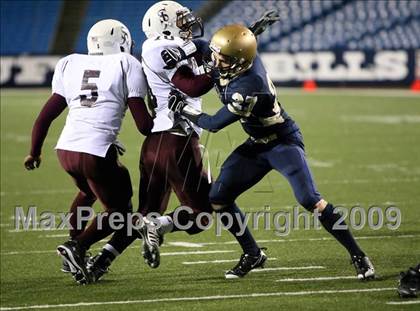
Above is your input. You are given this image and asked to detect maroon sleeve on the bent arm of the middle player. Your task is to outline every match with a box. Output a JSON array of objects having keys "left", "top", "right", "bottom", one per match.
[{"left": 171, "top": 66, "right": 214, "bottom": 97}]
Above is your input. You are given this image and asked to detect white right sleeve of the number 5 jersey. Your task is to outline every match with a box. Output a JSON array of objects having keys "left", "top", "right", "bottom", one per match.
[{"left": 126, "top": 56, "right": 147, "bottom": 98}]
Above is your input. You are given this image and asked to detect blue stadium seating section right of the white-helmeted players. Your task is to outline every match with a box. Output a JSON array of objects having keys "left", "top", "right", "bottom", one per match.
[{"left": 206, "top": 0, "right": 420, "bottom": 52}]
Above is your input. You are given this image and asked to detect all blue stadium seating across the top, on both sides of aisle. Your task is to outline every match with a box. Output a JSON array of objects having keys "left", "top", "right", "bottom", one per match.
[{"left": 1, "top": 0, "right": 420, "bottom": 55}]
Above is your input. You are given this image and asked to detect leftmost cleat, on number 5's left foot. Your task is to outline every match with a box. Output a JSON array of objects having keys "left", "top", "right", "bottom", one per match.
[{"left": 57, "top": 240, "right": 91, "bottom": 284}]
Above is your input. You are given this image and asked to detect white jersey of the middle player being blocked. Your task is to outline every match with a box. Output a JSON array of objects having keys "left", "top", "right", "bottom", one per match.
[{"left": 141, "top": 36, "right": 203, "bottom": 135}]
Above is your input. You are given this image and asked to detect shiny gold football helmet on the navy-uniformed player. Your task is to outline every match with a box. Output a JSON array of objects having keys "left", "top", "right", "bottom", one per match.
[{"left": 210, "top": 24, "right": 257, "bottom": 79}]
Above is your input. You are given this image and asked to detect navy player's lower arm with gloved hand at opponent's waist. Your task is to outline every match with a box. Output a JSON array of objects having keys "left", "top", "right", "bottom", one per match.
[{"left": 168, "top": 90, "right": 240, "bottom": 132}]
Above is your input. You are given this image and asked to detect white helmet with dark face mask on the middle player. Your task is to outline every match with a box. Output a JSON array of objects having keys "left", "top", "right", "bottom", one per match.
[{"left": 142, "top": 1, "right": 203, "bottom": 40}]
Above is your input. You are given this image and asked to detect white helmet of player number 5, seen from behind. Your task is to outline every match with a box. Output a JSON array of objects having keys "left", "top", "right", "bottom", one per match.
[{"left": 87, "top": 19, "right": 133, "bottom": 55}]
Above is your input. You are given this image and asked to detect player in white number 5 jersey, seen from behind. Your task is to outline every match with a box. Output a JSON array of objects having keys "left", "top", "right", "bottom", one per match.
[{"left": 24, "top": 19, "right": 153, "bottom": 283}]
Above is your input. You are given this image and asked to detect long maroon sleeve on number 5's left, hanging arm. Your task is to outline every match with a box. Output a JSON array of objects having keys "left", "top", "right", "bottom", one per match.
[{"left": 30, "top": 93, "right": 67, "bottom": 156}]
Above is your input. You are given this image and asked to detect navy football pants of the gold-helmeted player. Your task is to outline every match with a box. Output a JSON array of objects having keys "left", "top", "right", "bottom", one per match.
[{"left": 210, "top": 131, "right": 321, "bottom": 211}]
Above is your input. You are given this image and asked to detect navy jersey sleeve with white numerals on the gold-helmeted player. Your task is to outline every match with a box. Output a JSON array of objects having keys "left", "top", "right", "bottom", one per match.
[{"left": 226, "top": 79, "right": 261, "bottom": 118}]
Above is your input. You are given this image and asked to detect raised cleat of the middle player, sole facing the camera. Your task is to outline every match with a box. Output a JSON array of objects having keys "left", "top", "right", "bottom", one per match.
[{"left": 138, "top": 218, "right": 162, "bottom": 269}]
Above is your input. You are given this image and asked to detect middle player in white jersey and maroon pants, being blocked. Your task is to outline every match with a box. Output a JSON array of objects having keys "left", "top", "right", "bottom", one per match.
[{"left": 85, "top": 1, "right": 218, "bottom": 277}]
